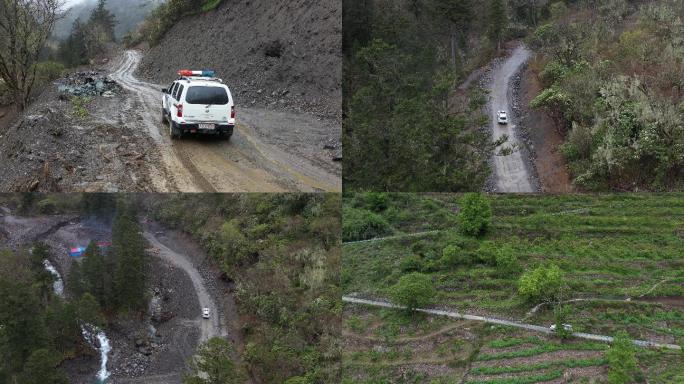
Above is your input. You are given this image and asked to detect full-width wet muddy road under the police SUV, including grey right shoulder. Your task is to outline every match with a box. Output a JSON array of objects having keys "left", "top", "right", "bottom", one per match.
[{"left": 110, "top": 51, "right": 342, "bottom": 192}]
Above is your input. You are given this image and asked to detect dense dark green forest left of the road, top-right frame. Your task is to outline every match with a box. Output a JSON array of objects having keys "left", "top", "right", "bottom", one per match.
[{"left": 343, "top": 0, "right": 542, "bottom": 191}]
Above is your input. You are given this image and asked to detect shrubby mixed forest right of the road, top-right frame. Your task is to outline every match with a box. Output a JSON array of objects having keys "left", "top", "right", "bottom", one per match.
[{"left": 528, "top": 0, "right": 684, "bottom": 190}]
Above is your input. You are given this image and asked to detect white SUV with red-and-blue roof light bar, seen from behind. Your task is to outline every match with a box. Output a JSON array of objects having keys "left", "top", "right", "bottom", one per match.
[{"left": 162, "top": 70, "right": 235, "bottom": 139}]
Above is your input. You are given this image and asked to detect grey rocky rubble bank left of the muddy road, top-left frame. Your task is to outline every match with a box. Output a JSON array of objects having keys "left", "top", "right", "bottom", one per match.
[{"left": 0, "top": 85, "right": 156, "bottom": 192}]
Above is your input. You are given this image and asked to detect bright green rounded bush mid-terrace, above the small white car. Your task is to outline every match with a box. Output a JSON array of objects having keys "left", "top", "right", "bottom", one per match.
[{"left": 518, "top": 265, "right": 564, "bottom": 301}]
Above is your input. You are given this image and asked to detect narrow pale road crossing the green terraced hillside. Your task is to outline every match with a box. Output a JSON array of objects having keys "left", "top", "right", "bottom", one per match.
[{"left": 342, "top": 296, "right": 682, "bottom": 350}]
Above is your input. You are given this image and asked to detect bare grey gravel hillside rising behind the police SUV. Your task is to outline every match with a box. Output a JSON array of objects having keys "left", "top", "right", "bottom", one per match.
[{"left": 139, "top": 0, "right": 342, "bottom": 116}]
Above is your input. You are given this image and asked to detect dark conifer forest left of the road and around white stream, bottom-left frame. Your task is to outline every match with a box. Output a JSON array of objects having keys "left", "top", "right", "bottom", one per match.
[{"left": 0, "top": 194, "right": 147, "bottom": 384}]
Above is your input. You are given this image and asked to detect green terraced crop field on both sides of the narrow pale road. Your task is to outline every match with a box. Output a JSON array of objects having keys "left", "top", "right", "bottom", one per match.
[{"left": 342, "top": 193, "right": 684, "bottom": 384}]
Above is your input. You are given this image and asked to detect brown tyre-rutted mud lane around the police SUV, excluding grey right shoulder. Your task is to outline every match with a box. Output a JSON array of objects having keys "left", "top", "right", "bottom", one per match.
[{"left": 111, "top": 51, "right": 341, "bottom": 192}]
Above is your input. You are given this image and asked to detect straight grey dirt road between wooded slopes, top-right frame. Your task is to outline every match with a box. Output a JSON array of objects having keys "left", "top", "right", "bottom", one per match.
[{"left": 489, "top": 46, "right": 536, "bottom": 193}]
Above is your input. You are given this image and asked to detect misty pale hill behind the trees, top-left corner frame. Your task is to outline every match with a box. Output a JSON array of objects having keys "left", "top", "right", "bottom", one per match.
[{"left": 53, "top": 0, "right": 165, "bottom": 40}]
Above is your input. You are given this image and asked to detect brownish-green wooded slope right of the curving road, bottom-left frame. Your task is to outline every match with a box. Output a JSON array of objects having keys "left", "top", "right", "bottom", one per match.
[{"left": 151, "top": 194, "right": 341, "bottom": 384}]
